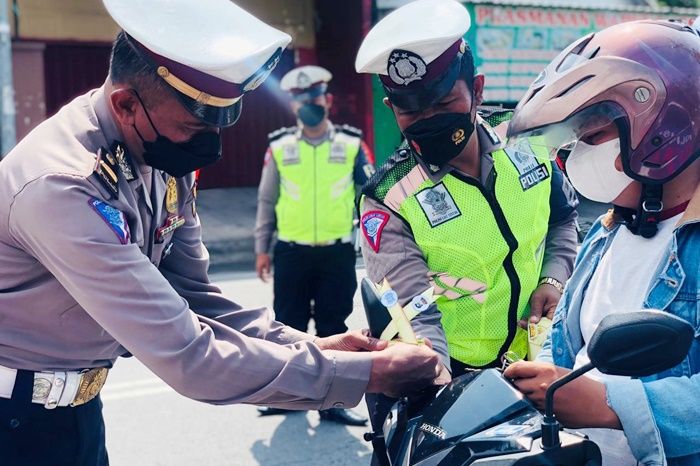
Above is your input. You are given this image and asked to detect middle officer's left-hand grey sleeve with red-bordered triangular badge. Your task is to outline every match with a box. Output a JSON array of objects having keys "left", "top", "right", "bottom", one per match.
[{"left": 360, "top": 197, "right": 450, "bottom": 368}]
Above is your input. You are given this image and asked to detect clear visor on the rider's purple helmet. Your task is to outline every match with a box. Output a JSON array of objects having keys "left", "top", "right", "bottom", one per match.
[{"left": 506, "top": 102, "right": 627, "bottom": 160}]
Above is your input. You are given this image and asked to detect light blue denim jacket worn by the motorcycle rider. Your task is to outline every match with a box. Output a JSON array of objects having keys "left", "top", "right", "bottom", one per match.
[{"left": 538, "top": 189, "right": 700, "bottom": 466}]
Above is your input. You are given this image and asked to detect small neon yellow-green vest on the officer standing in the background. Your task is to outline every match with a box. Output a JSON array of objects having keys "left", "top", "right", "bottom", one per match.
[{"left": 270, "top": 128, "right": 361, "bottom": 244}]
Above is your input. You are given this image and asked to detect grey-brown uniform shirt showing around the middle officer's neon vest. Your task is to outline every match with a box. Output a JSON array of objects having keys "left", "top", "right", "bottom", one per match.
[{"left": 361, "top": 118, "right": 578, "bottom": 367}]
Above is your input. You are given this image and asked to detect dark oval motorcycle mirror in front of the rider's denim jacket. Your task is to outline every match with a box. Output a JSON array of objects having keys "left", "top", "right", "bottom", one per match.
[{"left": 588, "top": 310, "right": 695, "bottom": 377}]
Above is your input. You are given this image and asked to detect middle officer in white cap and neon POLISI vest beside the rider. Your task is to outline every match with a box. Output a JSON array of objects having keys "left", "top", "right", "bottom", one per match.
[{"left": 355, "top": 0, "right": 577, "bottom": 452}]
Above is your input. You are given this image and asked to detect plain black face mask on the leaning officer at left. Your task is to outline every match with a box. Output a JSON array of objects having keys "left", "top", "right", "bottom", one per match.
[{"left": 133, "top": 91, "right": 221, "bottom": 178}]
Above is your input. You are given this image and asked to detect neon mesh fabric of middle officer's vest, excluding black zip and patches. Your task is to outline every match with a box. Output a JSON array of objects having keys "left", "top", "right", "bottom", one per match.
[{"left": 399, "top": 150, "right": 551, "bottom": 367}]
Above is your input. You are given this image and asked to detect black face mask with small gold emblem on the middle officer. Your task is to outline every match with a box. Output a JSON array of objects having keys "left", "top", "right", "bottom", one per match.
[{"left": 403, "top": 113, "right": 474, "bottom": 167}]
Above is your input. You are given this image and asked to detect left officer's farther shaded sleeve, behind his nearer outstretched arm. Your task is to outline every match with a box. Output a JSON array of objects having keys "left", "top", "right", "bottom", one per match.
[{"left": 159, "top": 173, "right": 313, "bottom": 344}]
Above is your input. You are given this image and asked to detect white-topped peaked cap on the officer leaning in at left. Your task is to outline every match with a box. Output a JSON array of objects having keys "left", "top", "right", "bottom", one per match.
[{"left": 103, "top": 0, "right": 291, "bottom": 126}]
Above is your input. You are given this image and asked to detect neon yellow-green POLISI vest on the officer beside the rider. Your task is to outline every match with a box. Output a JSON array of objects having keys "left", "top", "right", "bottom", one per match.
[{"left": 364, "top": 133, "right": 551, "bottom": 367}]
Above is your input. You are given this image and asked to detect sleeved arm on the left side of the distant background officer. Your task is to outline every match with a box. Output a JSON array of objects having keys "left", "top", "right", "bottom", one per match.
[{"left": 255, "top": 147, "right": 280, "bottom": 254}]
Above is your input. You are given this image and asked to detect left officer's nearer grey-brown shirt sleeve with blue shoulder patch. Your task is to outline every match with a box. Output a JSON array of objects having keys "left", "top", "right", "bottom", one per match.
[{"left": 9, "top": 175, "right": 360, "bottom": 409}]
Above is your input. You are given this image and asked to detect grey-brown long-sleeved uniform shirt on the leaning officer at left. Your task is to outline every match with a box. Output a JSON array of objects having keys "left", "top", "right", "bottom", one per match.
[{"left": 0, "top": 89, "right": 371, "bottom": 409}]
